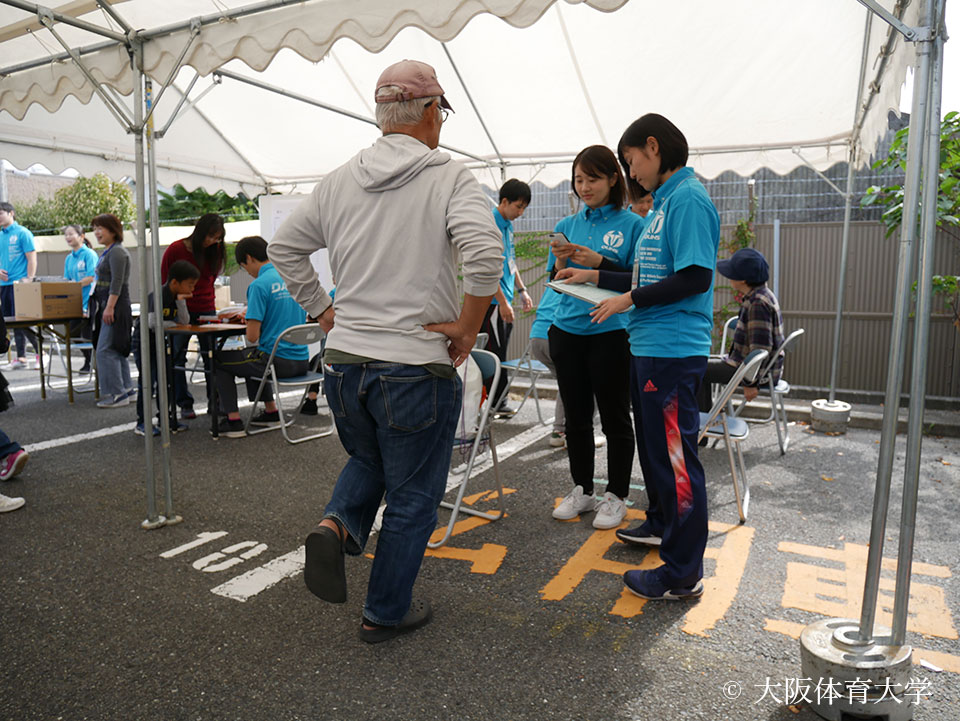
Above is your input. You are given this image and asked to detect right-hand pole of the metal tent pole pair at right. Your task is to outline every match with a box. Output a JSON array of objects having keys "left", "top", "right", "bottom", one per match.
[{"left": 893, "top": 0, "right": 944, "bottom": 646}]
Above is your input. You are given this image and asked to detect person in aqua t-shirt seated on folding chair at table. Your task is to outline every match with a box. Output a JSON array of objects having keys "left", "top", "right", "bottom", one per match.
[{"left": 216, "top": 235, "right": 309, "bottom": 438}]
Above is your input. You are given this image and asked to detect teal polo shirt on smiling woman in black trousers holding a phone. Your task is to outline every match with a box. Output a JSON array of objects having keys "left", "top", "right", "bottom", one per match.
[{"left": 548, "top": 205, "right": 644, "bottom": 335}]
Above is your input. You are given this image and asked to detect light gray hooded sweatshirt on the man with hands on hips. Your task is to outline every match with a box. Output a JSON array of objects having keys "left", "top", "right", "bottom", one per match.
[{"left": 267, "top": 134, "right": 503, "bottom": 365}]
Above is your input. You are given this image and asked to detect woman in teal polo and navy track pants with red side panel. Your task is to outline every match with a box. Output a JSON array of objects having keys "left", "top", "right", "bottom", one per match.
[{"left": 565, "top": 113, "right": 720, "bottom": 600}]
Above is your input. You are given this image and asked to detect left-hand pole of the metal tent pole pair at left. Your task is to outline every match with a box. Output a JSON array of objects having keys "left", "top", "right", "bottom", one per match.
[{"left": 132, "top": 40, "right": 167, "bottom": 529}]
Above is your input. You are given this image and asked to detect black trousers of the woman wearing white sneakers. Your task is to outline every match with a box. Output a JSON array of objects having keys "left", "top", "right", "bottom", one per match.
[{"left": 548, "top": 326, "right": 635, "bottom": 498}]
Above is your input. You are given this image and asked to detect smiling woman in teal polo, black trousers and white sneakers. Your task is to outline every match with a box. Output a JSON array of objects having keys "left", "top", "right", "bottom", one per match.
[{"left": 548, "top": 145, "right": 644, "bottom": 528}]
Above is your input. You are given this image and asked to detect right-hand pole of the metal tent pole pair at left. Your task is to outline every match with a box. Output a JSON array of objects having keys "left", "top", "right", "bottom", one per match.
[{"left": 145, "top": 80, "right": 183, "bottom": 526}]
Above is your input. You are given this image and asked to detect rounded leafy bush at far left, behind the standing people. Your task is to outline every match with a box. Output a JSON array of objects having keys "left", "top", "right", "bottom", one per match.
[{"left": 16, "top": 173, "right": 135, "bottom": 235}]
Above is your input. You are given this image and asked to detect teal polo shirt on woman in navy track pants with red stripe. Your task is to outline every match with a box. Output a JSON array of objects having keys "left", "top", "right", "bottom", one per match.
[{"left": 628, "top": 168, "right": 720, "bottom": 358}]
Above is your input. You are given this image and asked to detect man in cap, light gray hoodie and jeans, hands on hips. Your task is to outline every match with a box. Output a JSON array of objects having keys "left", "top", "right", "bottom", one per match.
[{"left": 267, "top": 60, "right": 503, "bottom": 643}]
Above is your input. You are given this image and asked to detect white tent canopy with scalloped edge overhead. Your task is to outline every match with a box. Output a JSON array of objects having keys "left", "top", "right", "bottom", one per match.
[{"left": 0, "top": 0, "right": 917, "bottom": 193}]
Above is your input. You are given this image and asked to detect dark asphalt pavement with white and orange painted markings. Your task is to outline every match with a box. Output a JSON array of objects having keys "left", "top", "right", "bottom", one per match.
[{"left": 0, "top": 371, "right": 960, "bottom": 721}]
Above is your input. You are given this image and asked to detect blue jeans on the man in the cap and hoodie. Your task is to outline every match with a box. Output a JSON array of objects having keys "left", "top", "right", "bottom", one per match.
[{"left": 323, "top": 362, "right": 462, "bottom": 626}]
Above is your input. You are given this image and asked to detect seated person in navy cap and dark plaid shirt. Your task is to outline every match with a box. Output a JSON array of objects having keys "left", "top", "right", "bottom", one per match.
[{"left": 698, "top": 248, "right": 783, "bottom": 413}]
